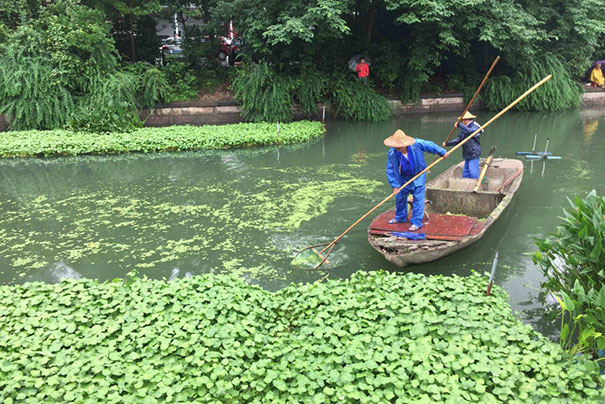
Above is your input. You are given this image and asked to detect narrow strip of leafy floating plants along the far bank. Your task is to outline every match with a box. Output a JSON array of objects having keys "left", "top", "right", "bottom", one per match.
[{"left": 0, "top": 121, "right": 323, "bottom": 157}]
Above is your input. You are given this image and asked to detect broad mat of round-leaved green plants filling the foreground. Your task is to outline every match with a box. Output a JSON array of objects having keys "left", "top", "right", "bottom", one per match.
[{"left": 0, "top": 272, "right": 605, "bottom": 403}]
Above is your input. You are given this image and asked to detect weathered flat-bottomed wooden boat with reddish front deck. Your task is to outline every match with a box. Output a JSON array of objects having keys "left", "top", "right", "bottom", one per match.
[{"left": 368, "top": 159, "right": 523, "bottom": 267}]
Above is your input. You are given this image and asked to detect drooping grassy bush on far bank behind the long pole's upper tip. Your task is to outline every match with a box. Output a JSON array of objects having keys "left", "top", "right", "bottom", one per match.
[{"left": 481, "top": 56, "right": 582, "bottom": 111}]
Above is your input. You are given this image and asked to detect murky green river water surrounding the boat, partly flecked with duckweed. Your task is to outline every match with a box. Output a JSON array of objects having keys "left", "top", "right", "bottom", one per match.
[{"left": 0, "top": 110, "right": 605, "bottom": 333}]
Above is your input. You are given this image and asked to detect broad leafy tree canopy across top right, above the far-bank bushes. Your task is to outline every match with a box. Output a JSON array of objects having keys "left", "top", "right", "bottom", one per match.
[{"left": 211, "top": 0, "right": 605, "bottom": 109}]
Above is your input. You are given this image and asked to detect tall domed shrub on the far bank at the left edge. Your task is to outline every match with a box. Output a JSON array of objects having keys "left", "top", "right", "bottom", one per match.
[{"left": 0, "top": 0, "right": 117, "bottom": 129}]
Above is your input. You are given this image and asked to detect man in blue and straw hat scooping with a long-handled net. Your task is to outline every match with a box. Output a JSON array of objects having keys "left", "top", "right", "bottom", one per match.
[{"left": 384, "top": 129, "right": 448, "bottom": 231}]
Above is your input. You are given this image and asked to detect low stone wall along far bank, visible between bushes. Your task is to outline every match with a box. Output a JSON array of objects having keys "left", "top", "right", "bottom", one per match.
[{"left": 0, "top": 88, "right": 605, "bottom": 131}]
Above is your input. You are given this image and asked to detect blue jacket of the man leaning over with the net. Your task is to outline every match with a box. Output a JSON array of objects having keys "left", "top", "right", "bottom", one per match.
[{"left": 387, "top": 138, "right": 446, "bottom": 188}]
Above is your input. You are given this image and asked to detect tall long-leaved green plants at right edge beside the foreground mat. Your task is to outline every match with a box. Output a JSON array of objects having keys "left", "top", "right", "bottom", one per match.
[{"left": 533, "top": 190, "right": 605, "bottom": 357}]
